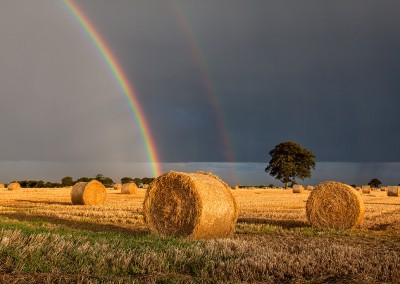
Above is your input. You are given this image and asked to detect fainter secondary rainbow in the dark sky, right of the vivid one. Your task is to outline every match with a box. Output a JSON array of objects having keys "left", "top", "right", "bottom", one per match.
[{"left": 171, "top": 0, "right": 235, "bottom": 162}]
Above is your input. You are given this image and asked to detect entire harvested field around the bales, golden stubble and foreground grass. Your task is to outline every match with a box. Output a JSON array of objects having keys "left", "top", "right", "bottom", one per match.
[{"left": 0, "top": 188, "right": 400, "bottom": 283}]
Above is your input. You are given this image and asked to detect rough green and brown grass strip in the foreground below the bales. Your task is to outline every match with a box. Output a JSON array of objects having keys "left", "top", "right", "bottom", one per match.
[{"left": 0, "top": 218, "right": 400, "bottom": 283}]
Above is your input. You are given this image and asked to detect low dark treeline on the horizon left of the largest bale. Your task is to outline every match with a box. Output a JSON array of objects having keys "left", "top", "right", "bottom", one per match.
[{"left": 9, "top": 174, "right": 154, "bottom": 188}]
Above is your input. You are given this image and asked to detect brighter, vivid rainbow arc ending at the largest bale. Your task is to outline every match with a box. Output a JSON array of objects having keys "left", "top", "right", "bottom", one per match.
[{"left": 63, "top": 0, "right": 162, "bottom": 177}]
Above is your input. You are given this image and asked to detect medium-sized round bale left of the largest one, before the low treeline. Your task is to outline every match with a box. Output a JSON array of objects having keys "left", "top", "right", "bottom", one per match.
[{"left": 71, "top": 180, "right": 106, "bottom": 205}]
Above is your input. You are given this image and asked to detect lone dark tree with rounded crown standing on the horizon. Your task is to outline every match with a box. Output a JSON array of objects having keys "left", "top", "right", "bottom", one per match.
[{"left": 265, "top": 141, "right": 315, "bottom": 188}]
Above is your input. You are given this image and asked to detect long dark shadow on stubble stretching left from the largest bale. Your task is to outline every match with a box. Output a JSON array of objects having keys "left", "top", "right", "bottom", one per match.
[{"left": 0, "top": 212, "right": 149, "bottom": 236}]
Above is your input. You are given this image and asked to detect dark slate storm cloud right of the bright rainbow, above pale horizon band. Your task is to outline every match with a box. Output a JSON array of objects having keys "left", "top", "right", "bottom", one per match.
[{"left": 73, "top": 1, "right": 400, "bottom": 161}]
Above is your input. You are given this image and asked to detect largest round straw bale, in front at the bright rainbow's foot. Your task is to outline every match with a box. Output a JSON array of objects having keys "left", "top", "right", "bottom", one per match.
[{"left": 143, "top": 171, "right": 238, "bottom": 239}]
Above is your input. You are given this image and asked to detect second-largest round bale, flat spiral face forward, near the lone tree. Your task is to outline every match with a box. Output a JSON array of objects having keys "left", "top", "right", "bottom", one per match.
[{"left": 306, "top": 181, "right": 365, "bottom": 229}]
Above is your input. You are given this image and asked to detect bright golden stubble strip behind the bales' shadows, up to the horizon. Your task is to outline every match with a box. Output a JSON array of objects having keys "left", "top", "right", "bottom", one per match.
[{"left": 0, "top": 188, "right": 400, "bottom": 232}]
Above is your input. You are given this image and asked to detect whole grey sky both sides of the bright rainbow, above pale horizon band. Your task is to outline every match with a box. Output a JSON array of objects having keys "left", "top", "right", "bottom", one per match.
[{"left": 0, "top": 0, "right": 400, "bottom": 181}]
